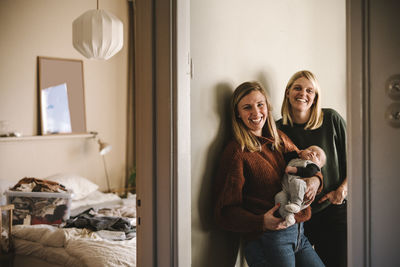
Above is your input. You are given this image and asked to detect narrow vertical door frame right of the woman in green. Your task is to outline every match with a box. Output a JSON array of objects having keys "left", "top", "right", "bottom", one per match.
[{"left": 346, "top": 0, "right": 371, "bottom": 267}]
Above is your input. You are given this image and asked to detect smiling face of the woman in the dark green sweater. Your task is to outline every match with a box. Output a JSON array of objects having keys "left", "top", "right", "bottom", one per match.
[{"left": 286, "top": 77, "right": 316, "bottom": 116}]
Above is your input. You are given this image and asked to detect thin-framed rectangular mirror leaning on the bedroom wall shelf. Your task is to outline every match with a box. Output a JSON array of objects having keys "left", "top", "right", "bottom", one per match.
[{"left": 38, "top": 57, "right": 86, "bottom": 135}]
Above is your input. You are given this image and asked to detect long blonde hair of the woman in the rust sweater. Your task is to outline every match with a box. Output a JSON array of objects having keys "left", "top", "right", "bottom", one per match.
[{"left": 231, "top": 82, "right": 282, "bottom": 152}]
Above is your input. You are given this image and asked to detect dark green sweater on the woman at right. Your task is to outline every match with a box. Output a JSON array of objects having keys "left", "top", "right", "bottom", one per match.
[{"left": 277, "top": 109, "right": 347, "bottom": 216}]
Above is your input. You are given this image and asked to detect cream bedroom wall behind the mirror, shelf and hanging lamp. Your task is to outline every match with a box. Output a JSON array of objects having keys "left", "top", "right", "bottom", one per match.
[{"left": 0, "top": 0, "right": 128, "bottom": 193}]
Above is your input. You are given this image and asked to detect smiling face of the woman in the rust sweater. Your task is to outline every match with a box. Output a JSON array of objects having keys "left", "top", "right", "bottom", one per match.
[{"left": 237, "top": 90, "right": 268, "bottom": 136}]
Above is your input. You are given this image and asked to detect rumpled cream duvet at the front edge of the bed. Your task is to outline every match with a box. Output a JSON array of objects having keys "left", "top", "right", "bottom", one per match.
[{"left": 13, "top": 225, "right": 136, "bottom": 267}]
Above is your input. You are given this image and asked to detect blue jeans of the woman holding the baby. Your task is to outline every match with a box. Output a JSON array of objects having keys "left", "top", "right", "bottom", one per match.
[{"left": 244, "top": 223, "right": 325, "bottom": 267}]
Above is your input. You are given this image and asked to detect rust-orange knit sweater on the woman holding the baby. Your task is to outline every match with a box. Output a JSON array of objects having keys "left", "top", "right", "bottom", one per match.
[{"left": 214, "top": 131, "right": 322, "bottom": 239}]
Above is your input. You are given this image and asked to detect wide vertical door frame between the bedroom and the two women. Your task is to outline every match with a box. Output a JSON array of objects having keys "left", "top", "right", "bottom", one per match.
[{"left": 135, "top": 0, "right": 191, "bottom": 266}]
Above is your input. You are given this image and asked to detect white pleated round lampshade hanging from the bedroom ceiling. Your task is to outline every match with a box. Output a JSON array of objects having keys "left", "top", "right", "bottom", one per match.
[{"left": 72, "top": 9, "right": 124, "bottom": 60}]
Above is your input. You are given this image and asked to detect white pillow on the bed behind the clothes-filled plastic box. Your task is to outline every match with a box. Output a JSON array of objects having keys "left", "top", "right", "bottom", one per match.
[{"left": 44, "top": 173, "right": 99, "bottom": 200}]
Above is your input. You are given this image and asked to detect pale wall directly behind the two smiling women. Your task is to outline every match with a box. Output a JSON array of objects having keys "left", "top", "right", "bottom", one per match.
[{"left": 191, "top": 0, "right": 346, "bottom": 266}]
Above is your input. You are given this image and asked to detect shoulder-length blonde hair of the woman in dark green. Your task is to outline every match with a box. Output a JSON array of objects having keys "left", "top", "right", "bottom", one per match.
[{"left": 281, "top": 70, "right": 324, "bottom": 130}]
